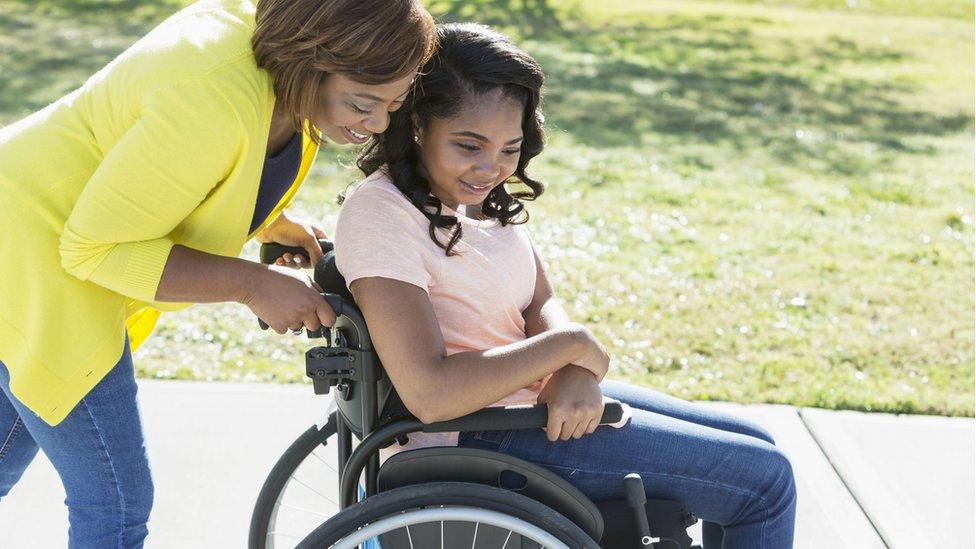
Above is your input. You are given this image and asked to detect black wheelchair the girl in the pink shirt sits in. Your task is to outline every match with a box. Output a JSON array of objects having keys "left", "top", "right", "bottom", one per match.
[{"left": 248, "top": 240, "right": 697, "bottom": 549}]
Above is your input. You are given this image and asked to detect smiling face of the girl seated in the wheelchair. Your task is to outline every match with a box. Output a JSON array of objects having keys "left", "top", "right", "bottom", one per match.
[{"left": 415, "top": 90, "right": 523, "bottom": 210}]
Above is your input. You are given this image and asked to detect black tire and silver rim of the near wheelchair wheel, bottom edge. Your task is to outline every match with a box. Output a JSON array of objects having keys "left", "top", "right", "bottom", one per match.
[{"left": 298, "top": 482, "right": 599, "bottom": 549}]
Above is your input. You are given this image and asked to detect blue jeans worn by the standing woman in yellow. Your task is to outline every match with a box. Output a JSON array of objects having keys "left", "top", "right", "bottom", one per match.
[{"left": 0, "top": 343, "right": 153, "bottom": 549}]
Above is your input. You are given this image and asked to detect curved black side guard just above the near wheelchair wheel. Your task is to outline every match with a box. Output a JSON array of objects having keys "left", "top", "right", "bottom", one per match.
[{"left": 378, "top": 447, "right": 604, "bottom": 540}]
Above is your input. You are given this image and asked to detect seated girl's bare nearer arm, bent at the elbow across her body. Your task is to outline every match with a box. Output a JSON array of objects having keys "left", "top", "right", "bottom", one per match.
[{"left": 350, "top": 277, "right": 605, "bottom": 423}]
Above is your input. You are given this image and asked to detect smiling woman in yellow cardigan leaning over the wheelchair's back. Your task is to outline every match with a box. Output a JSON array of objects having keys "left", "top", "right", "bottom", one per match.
[{"left": 0, "top": 0, "right": 435, "bottom": 548}]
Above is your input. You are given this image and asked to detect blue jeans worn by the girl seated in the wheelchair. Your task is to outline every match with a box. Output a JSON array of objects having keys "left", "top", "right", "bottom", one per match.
[{"left": 458, "top": 381, "right": 796, "bottom": 549}]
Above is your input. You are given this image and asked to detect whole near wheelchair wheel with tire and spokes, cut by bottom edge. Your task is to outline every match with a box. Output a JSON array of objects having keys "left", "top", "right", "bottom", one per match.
[{"left": 298, "top": 482, "right": 599, "bottom": 549}]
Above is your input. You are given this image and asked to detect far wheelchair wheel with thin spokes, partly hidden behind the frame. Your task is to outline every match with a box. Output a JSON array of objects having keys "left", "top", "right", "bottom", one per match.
[{"left": 248, "top": 412, "right": 339, "bottom": 549}]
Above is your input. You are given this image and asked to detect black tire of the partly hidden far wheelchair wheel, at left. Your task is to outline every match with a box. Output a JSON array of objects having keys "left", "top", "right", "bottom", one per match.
[{"left": 247, "top": 412, "right": 336, "bottom": 549}]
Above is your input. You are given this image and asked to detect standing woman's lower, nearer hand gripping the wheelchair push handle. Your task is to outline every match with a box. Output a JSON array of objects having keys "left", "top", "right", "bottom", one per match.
[{"left": 240, "top": 265, "right": 335, "bottom": 334}]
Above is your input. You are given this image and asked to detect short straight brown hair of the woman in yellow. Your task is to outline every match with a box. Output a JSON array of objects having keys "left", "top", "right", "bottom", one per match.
[{"left": 251, "top": 0, "right": 437, "bottom": 146}]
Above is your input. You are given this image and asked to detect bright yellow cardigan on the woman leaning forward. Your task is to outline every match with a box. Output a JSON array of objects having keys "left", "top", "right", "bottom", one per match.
[{"left": 0, "top": 0, "right": 317, "bottom": 425}]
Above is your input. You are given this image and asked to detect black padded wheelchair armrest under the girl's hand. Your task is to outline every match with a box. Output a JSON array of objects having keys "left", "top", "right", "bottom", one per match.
[{"left": 422, "top": 401, "right": 624, "bottom": 433}]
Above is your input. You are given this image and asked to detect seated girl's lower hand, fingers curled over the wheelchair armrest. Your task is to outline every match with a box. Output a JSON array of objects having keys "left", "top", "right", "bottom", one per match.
[{"left": 538, "top": 364, "right": 603, "bottom": 442}]
